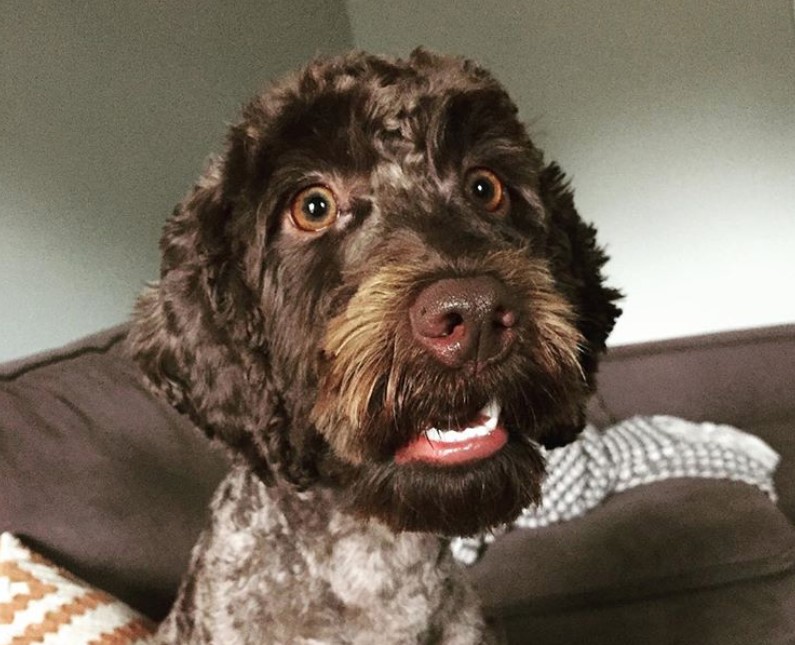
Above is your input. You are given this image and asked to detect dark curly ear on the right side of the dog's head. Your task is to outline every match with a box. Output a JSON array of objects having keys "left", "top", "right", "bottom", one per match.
[{"left": 539, "top": 163, "right": 621, "bottom": 446}]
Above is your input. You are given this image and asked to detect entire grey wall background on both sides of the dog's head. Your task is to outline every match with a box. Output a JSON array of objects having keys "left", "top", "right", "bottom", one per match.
[{"left": 0, "top": 0, "right": 795, "bottom": 360}]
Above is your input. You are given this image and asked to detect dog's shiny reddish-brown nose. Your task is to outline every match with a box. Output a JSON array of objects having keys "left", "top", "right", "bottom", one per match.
[{"left": 409, "top": 276, "right": 517, "bottom": 368}]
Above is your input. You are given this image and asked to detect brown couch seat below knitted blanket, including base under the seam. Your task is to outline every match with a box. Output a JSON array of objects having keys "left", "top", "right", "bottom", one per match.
[{"left": 470, "top": 479, "right": 795, "bottom": 645}]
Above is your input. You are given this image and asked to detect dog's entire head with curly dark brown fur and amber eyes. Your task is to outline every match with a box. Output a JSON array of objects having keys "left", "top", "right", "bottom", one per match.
[{"left": 130, "top": 51, "right": 618, "bottom": 535}]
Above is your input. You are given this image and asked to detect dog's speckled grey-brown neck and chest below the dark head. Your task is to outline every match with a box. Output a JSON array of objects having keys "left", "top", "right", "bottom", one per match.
[{"left": 158, "top": 465, "right": 498, "bottom": 644}]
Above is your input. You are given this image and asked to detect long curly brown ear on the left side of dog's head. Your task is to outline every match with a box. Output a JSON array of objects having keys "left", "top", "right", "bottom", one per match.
[{"left": 128, "top": 128, "right": 302, "bottom": 482}]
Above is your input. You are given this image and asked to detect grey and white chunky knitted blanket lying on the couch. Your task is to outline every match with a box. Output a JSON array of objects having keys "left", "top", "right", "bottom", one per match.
[{"left": 450, "top": 416, "right": 779, "bottom": 564}]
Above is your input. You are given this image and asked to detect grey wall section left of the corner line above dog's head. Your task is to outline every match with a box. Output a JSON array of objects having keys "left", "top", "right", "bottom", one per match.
[{"left": 0, "top": 0, "right": 352, "bottom": 360}]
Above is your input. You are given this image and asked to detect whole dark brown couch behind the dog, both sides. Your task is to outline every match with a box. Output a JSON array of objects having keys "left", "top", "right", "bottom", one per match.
[{"left": 0, "top": 325, "right": 795, "bottom": 645}]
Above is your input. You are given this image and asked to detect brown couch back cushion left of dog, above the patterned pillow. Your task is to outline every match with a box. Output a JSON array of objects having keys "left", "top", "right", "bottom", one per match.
[{"left": 0, "top": 327, "right": 226, "bottom": 617}]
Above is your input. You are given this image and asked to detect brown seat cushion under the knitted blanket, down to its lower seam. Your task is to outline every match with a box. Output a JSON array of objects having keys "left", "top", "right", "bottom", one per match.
[{"left": 470, "top": 479, "right": 795, "bottom": 615}]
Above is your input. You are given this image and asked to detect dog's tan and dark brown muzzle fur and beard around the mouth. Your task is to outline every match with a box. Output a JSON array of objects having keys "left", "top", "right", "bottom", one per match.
[{"left": 311, "top": 252, "right": 586, "bottom": 536}]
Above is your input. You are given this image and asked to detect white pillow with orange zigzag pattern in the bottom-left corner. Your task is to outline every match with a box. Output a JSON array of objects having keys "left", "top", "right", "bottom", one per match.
[{"left": 0, "top": 533, "right": 154, "bottom": 645}]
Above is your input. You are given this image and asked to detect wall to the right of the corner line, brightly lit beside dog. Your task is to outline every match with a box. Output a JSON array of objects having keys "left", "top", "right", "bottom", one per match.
[{"left": 348, "top": 0, "right": 795, "bottom": 343}]
